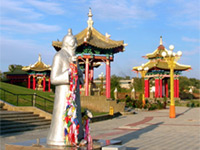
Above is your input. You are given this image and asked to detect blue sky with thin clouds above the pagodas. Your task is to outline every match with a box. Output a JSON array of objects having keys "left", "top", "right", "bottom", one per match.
[{"left": 0, "top": 0, "right": 200, "bottom": 79}]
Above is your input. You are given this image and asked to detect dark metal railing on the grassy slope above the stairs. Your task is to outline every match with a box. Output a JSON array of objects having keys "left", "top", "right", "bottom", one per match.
[{"left": 0, "top": 88, "right": 54, "bottom": 113}]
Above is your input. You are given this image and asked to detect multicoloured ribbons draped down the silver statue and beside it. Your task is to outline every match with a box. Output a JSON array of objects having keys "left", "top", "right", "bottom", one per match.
[{"left": 64, "top": 63, "right": 92, "bottom": 146}]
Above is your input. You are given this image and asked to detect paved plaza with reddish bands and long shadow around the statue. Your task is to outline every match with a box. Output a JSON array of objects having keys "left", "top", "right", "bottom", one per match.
[{"left": 0, "top": 107, "right": 200, "bottom": 150}]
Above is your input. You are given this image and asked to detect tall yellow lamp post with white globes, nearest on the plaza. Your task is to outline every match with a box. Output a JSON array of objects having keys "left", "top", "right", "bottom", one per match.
[{"left": 162, "top": 45, "right": 182, "bottom": 118}]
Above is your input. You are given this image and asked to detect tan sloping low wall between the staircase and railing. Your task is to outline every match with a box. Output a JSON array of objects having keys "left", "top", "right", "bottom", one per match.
[{"left": 0, "top": 100, "right": 52, "bottom": 119}]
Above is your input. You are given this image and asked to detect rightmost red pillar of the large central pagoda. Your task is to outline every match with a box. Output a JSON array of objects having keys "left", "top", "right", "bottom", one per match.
[{"left": 106, "top": 59, "right": 110, "bottom": 98}]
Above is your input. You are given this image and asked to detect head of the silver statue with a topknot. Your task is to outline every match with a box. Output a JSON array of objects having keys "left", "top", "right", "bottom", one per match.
[{"left": 62, "top": 29, "right": 77, "bottom": 51}]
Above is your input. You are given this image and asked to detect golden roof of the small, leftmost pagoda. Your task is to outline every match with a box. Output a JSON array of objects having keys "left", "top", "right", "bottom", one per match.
[{"left": 22, "top": 54, "right": 51, "bottom": 71}]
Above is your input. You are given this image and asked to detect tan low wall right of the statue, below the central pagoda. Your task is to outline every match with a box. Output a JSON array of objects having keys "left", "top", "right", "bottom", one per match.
[{"left": 81, "top": 96, "right": 125, "bottom": 112}]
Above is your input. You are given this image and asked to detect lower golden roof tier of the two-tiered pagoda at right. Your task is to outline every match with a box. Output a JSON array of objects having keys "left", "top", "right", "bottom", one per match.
[{"left": 133, "top": 59, "right": 191, "bottom": 71}]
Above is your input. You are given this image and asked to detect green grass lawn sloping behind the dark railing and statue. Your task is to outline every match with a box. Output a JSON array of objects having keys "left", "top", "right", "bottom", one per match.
[{"left": 0, "top": 82, "right": 108, "bottom": 116}]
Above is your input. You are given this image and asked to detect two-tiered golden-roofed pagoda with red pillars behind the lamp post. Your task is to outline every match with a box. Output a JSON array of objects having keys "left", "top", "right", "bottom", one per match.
[{"left": 133, "top": 36, "right": 191, "bottom": 98}]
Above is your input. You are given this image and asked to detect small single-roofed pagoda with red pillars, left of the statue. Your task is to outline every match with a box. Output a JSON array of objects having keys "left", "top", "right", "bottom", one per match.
[{"left": 22, "top": 54, "right": 51, "bottom": 92}]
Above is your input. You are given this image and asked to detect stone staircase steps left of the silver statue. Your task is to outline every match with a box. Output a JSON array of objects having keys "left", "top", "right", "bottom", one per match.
[{"left": 0, "top": 109, "right": 51, "bottom": 135}]
